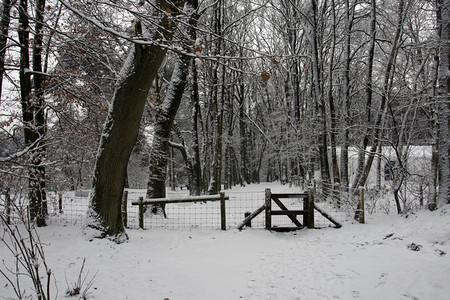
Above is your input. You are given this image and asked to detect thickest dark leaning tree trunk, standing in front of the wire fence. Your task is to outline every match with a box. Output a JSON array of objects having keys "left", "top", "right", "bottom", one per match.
[{"left": 85, "top": 0, "right": 184, "bottom": 242}]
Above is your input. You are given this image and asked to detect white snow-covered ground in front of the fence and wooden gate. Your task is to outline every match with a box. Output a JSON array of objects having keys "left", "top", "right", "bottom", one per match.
[{"left": 0, "top": 185, "right": 450, "bottom": 300}]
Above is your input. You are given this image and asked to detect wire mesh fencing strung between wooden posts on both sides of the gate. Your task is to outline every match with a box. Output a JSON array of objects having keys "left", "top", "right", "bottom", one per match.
[{"left": 0, "top": 189, "right": 348, "bottom": 229}]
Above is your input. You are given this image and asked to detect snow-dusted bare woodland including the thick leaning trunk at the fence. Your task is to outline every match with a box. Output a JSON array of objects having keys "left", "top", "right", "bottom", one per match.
[{"left": 0, "top": 0, "right": 450, "bottom": 237}]
